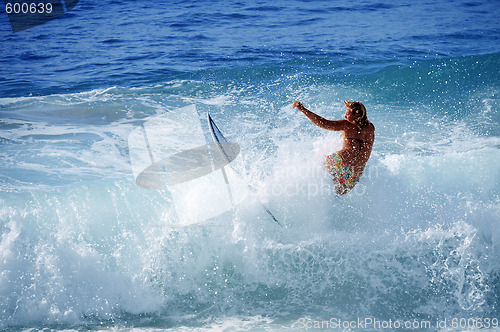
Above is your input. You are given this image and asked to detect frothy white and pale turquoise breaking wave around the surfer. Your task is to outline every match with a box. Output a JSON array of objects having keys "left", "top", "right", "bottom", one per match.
[{"left": 0, "top": 54, "right": 500, "bottom": 331}]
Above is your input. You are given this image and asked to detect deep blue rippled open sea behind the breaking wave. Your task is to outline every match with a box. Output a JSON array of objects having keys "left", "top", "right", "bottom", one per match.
[{"left": 0, "top": 1, "right": 499, "bottom": 97}]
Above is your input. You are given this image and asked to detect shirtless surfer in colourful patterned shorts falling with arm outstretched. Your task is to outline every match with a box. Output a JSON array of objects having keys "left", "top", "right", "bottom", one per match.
[{"left": 292, "top": 100, "right": 375, "bottom": 195}]
